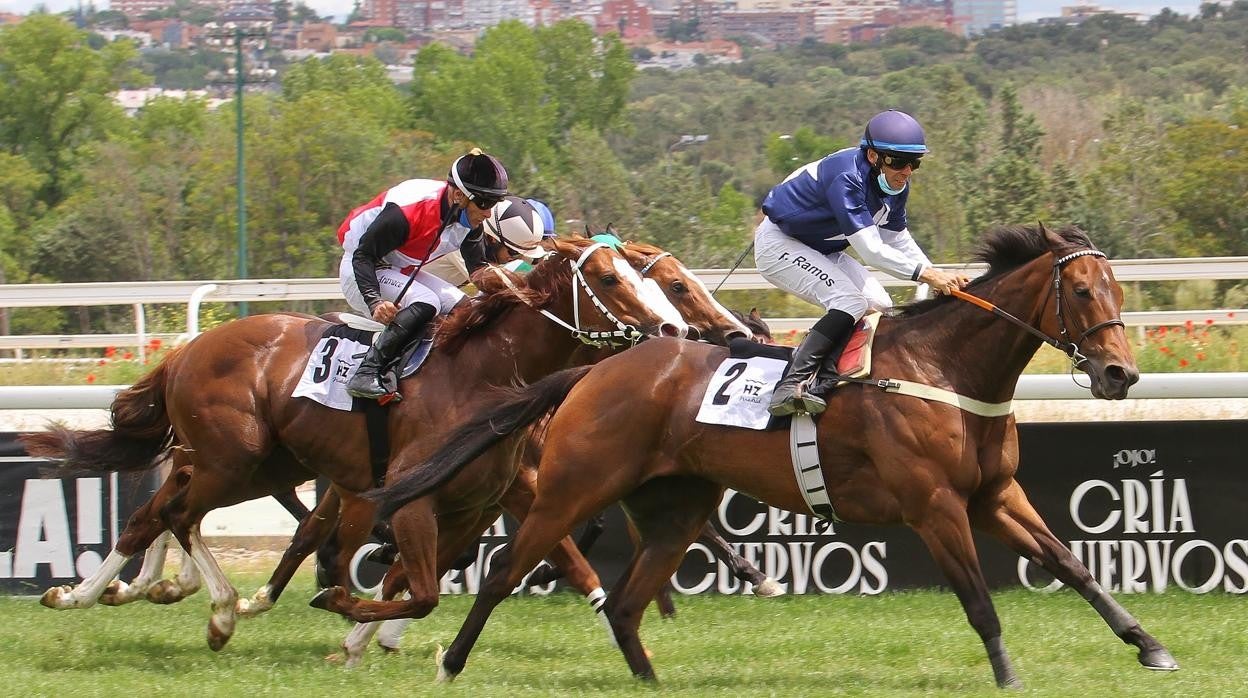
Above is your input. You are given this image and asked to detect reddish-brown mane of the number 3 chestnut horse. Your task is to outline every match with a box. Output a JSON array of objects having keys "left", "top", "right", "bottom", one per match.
[{"left": 433, "top": 237, "right": 594, "bottom": 351}]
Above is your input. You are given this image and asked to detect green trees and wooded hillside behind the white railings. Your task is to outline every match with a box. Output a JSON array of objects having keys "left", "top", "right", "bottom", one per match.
[{"left": 0, "top": 0, "right": 1248, "bottom": 332}]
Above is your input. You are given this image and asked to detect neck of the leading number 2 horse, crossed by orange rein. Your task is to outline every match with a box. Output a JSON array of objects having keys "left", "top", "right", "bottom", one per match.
[{"left": 895, "top": 255, "right": 1053, "bottom": 402}]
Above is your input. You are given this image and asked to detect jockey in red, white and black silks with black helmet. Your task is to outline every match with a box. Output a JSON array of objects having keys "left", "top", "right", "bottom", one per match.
[{"left": 338, "top": 149, "right": 507, "bottom": 398}]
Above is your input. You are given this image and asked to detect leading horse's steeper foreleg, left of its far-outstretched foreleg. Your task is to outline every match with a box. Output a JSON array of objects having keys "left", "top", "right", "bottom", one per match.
[{"left": 907, "top": 491, "right": 1022, "bottom": 688}]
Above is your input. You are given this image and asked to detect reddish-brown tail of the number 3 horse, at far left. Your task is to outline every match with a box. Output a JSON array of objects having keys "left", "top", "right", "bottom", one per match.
[{"left": 19, "top": 348, "right": 181, "bottom": 472}]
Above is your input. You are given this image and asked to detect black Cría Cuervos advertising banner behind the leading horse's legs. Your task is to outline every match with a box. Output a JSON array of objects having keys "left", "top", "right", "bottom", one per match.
[{"left": 344, "top": 421, "right": 1248, "bottom": 594}]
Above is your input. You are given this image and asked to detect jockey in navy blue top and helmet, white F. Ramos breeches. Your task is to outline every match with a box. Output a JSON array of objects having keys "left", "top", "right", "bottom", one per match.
[{"left": 754, "top": 110, "right": 967, "bottom": 416}]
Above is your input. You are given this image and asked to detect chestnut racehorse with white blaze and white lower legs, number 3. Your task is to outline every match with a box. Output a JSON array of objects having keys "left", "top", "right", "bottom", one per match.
[{"left": 22, "top": 240, "right": 685, "bottom": 649}]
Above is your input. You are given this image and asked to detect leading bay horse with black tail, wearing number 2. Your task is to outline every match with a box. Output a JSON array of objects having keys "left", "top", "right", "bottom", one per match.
[{"left": 372, "top": 226, "right": 1177, "bottom": 687}]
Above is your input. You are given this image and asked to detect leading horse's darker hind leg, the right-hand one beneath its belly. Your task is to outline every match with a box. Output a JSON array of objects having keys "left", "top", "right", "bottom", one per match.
[{"left": 607, "top": 477, "right": 724, "bottom": 681}]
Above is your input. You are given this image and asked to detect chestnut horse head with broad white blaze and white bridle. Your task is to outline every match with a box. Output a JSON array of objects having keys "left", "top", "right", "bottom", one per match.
[{"left": 541, "top": 238, "right": 689, "bottom": 341}]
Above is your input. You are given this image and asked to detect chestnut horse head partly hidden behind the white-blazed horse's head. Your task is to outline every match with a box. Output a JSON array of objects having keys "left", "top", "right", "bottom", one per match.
[{"left": 620, "top": 242, "right": 750, "bottom": 346}]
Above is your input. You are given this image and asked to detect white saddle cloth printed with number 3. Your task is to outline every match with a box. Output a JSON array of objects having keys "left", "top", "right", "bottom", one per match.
[{"left": 291, "top": 325, "right": 433, "bottom": 412}]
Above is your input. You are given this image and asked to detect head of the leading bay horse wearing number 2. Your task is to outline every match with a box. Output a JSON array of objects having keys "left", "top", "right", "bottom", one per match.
[{"left": 1040, "top": 225, "right": 1139, "bottom": 400}]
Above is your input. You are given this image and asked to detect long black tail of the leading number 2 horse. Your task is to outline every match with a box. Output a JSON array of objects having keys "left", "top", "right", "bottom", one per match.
[{"left": 362, "top": 366, "right": 592, "bottom": 519}]
